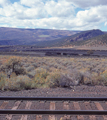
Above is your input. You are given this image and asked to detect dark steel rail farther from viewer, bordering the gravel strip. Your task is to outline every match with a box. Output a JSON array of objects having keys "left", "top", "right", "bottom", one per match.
[{"left": 0, "top": 96, "right": 107, "bottom": 101}]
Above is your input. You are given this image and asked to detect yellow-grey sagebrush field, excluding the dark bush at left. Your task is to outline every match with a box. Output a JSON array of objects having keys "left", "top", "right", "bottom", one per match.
[{"left": 0, "top": 56, "right": 107, "bottom": 90}]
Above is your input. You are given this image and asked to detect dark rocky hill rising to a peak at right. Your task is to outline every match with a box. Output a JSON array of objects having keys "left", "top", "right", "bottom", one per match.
[{"left": 37, "top": 29, "right": 105, "bottom": 46}]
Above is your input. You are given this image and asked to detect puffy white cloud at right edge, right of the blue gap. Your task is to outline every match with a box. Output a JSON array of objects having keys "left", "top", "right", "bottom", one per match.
[{"left": 77, "top": 5, "right": 107, "bottom": 24}]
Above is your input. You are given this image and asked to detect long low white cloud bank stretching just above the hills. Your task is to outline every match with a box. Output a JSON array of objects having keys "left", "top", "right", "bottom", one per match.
[{"left": 0, "top": 13, "right": 104, "bottom": 30}]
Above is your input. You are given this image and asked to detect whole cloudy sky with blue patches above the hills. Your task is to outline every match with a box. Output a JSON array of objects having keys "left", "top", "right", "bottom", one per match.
[{"left": 0, "top": 0, "right": 107, "bottom": 31}]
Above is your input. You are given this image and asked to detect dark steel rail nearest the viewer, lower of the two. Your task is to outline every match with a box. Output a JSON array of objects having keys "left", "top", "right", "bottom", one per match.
[{"left": 0, "top": 109, "right": 107, "bottom": 115}]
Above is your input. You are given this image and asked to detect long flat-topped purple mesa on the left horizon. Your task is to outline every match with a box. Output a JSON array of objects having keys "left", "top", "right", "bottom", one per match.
[{"left": 0, "top": 27, "right": 79, "bottom": 45}]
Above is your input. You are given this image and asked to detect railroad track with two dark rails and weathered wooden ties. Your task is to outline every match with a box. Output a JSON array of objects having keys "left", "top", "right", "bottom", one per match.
[{"left": 0, "top": 97, "right": 107, "bottom": 120}]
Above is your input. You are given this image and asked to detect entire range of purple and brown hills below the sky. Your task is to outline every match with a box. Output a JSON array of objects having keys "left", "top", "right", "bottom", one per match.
[{"left": 0, "top": 28, "right": 107, "bottom": 47}]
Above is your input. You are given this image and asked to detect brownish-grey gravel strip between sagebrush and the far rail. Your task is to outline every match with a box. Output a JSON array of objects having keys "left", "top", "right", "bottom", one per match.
[{"left": 0, "top": 85, "right": 107, "bottom": 97}]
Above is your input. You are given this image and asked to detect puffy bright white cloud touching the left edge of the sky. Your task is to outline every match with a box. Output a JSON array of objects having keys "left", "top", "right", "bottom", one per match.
[{"left": 0, "top": 2, "right": 46, "bottom": 19}]
